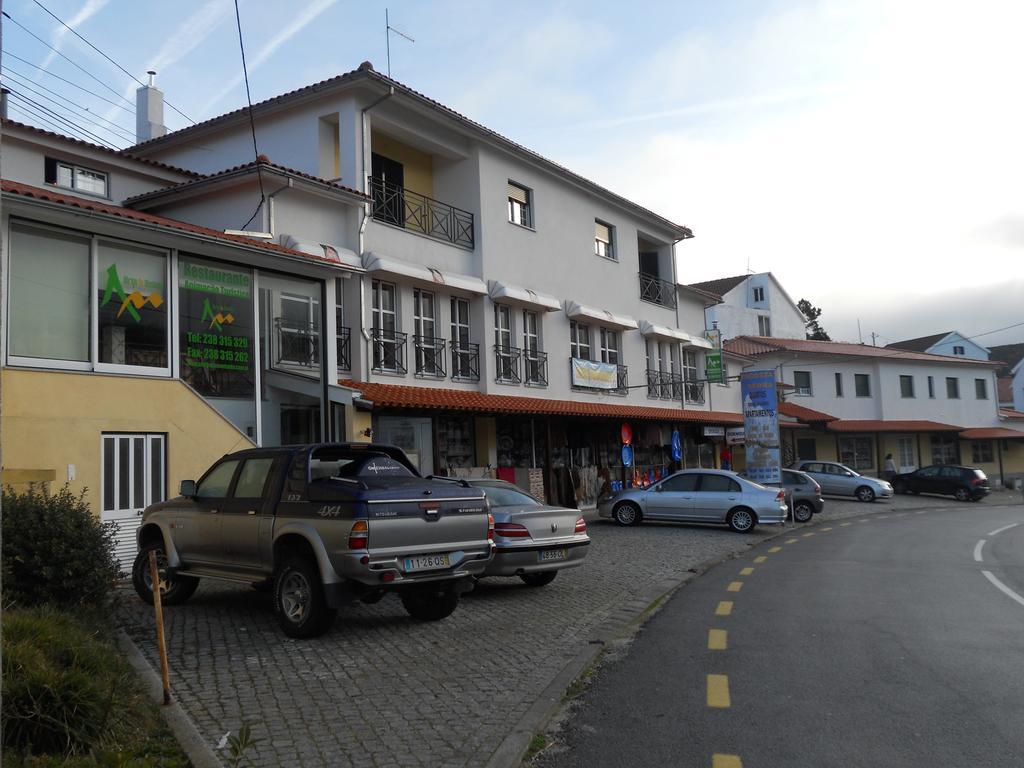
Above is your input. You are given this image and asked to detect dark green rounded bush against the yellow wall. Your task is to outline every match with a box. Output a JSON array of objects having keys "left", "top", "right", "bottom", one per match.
[{"left": 2, "top": 485, "right": 118, "bottom": 607}]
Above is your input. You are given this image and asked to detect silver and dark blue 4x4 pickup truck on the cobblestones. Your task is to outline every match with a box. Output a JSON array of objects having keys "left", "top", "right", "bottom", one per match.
[{"left": 132, "top": 443, "right": 494, "bottom": 638}]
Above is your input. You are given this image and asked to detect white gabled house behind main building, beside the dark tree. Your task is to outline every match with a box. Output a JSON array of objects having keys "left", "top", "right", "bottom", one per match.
[{"left": 690, "top": 272, "right": 807, "bottom": 339}]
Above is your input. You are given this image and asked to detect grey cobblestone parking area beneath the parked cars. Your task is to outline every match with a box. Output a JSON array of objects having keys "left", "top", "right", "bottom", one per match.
[{"left": 119, "top": 489, "right": 1015, "bottom": 768}]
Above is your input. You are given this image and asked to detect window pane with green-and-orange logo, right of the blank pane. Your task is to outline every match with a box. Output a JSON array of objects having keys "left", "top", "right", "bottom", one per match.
[{"left": 96, "top": 242, "right": 168, "bottom": 369}]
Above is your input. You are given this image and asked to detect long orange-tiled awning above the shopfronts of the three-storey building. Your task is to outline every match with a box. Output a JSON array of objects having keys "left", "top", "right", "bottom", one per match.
[{"left": 339, "top": 381, "right": 743, "bottom": 427}]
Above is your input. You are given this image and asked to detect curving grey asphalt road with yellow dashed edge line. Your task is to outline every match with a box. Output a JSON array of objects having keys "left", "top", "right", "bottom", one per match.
[{"left": 536, "top": 502, "right": 1024, "bottom": 768}]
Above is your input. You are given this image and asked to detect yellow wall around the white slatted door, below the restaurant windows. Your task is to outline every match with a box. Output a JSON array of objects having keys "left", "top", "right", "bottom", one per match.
[{"left": 0, "top": 369, "right": 253, "bottom": 515}]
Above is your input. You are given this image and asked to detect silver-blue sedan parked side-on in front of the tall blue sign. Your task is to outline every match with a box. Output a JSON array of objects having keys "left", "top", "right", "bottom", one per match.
[{"left": 597, "top": 469, "right": 788, "bottom": 532}]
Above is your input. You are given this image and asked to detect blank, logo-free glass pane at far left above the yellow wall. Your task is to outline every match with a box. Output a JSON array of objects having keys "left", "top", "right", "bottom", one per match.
[{"left": 9, "top": 224, "right": 89, "bottom": 362}]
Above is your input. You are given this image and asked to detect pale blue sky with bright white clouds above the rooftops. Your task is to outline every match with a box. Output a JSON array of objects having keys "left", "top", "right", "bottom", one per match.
[{"left": 3, "top": 0, "right": 1024, "bottom": 346}]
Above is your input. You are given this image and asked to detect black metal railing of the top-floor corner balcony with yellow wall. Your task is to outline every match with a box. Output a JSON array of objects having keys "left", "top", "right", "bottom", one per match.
[{"left": 369, "top": 176, "right": 473, "bottom": 250}]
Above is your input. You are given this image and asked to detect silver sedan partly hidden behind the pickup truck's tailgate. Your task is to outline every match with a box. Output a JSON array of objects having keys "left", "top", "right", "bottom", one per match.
[{"left": 469, "top": 479, "right": 590, "bottom": 587}]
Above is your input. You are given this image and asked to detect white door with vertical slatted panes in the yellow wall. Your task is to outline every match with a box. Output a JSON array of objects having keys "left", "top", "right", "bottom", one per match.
[{"left": 100, "top": 434, "right": 167, "bottom": 572}]
